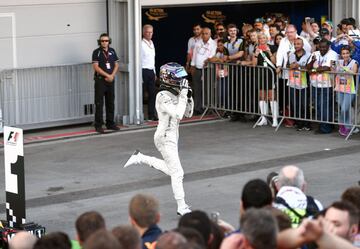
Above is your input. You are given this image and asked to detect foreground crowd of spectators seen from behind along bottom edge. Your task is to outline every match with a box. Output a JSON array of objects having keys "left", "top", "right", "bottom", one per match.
[{"left": 9, "top": 165, "right": 360, "bottom": 249}]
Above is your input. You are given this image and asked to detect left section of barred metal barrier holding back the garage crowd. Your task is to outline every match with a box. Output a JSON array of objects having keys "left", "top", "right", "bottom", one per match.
[{"left": 203, "top": 63, "right": 276, "bottom": 117}]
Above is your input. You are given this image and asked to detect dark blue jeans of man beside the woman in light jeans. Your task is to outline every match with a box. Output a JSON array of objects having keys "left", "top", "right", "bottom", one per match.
[{"left": 312, "top": 87, "right": 333, "bottom": 133}]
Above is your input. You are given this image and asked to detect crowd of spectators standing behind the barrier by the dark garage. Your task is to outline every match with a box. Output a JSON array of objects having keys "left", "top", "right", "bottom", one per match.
[{"left": 186, "top": 14, "right": 360, "bottom": 136}]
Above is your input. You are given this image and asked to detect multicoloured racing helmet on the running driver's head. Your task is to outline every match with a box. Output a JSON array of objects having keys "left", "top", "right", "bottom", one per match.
[{"left": 160, "top": 62, "right": 188, "bottom": 88}]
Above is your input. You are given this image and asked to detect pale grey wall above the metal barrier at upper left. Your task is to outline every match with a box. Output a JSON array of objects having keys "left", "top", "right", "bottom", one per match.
[{"left": 0, "top": 0, "right": 106, "bottom": 69}]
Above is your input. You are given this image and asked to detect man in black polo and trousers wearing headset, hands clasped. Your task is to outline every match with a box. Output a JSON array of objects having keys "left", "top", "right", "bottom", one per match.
[{"left": 92, "top": 34, "right": 119, "bottom": 133}]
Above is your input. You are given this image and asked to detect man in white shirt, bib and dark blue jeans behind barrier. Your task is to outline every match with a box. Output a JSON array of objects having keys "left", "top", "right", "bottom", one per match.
[{"left": 307, "top": 39, "right": 338, "bottom": 134}]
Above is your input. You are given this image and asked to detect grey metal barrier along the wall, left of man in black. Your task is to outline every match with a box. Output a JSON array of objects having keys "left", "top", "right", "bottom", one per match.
[{"left": 0, "top": 63, "right": 94, "bottom": 129}]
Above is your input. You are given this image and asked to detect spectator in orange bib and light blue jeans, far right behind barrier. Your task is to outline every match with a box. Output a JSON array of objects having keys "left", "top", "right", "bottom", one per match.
[{"left": 335, "top": 46, "right": 358, "bottom": 136}]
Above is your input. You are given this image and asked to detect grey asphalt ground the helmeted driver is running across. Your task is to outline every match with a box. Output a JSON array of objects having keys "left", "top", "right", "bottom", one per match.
[{"left": 0, "top": 120, "right": 360, "bottom": 238}]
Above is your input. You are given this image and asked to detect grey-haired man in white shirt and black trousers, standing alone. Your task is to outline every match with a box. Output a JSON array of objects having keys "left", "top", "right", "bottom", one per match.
[{"left": 141, "top": 24, "right": 157, "bottom": 120}]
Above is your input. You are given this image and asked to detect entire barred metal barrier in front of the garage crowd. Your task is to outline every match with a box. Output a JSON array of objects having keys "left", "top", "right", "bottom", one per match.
[{"left": 202, "top": 63, "right": 360, "bottom": 139}]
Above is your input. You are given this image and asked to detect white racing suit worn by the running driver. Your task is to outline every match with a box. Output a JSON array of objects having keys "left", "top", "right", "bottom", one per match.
[{"left": 141, "top": 88, "right": 194, "bottom": 209}]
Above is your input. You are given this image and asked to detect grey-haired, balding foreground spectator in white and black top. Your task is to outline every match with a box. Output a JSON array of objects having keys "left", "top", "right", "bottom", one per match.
[{"left": 274, "top": 165, "right": 323, "bottom": 227}]
